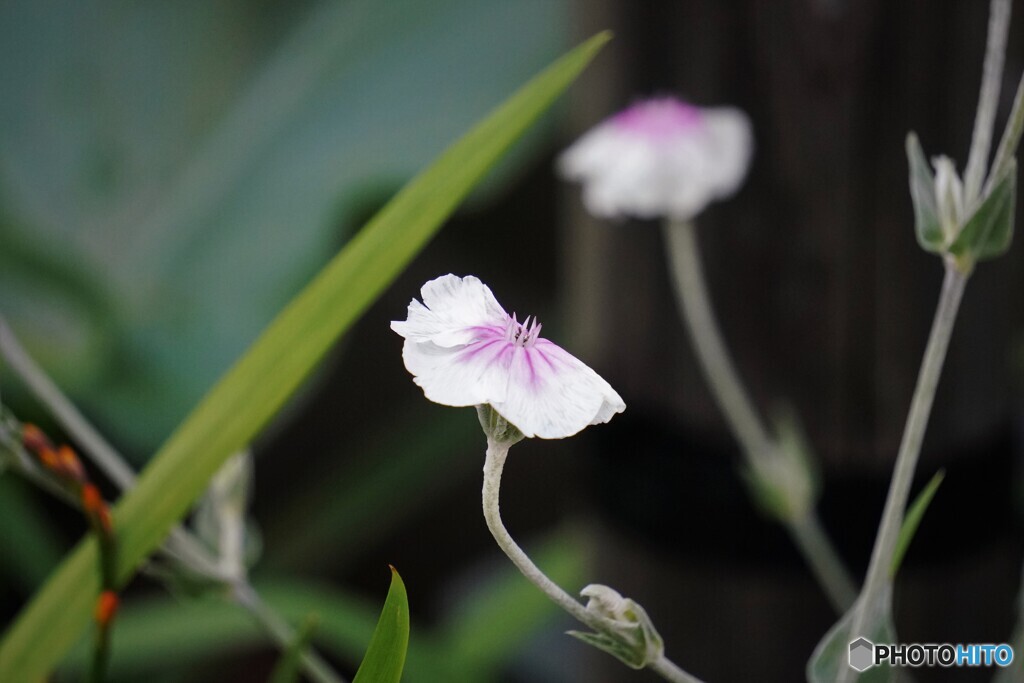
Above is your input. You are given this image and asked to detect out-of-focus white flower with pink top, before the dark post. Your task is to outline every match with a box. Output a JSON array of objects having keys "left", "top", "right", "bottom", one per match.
[{"left": 558, "top": 97, "right": 754, "bottom": 220}]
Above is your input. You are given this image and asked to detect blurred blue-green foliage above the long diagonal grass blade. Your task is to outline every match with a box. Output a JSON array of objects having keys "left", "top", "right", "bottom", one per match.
[{"left": 0, "top": 0, "right": 567, "bottom": 458}]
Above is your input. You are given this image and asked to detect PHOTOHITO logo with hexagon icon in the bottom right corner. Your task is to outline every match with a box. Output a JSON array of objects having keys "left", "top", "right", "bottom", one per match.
[{"left": 850, "top": 638, "right": 1014, "bottom": 672}]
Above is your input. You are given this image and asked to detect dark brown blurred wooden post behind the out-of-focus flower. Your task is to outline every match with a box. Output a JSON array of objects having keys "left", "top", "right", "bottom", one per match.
[{"left": 564, "top": 0, "right": 1024, "bottom": 681}]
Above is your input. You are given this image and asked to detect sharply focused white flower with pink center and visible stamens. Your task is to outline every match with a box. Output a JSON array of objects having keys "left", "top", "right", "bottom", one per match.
[{"left": 391, "top": 274, "right": 626, "bottom": 438}]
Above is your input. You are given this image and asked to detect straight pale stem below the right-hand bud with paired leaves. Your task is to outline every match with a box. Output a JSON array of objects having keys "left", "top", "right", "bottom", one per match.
[{"left": 850, "top": 262, "right": 969, "bottom": 671}]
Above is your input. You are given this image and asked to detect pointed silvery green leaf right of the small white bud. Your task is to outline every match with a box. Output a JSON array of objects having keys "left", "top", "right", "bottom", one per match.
[{"left": 949, "top": 161, "right": 1017, "bottom": 261}]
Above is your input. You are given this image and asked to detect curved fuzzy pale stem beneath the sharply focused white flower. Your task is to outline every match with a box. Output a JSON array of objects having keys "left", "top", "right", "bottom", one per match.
[{"left": 482, "top": 437, "right": 700, "bottom": 683}]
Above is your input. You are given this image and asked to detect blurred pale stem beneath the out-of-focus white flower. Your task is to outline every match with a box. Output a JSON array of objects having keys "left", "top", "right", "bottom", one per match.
[{"left": 664, "top": 221, "right": 857, "bottom": 613}]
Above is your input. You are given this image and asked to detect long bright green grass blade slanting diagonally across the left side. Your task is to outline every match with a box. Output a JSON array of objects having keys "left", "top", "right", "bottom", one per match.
[{"left": 0, "top": 34, "right": 609, "bottom": 681}]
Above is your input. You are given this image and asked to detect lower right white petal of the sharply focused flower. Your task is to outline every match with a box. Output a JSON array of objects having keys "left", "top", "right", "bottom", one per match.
[{"left": 489, "top": 339, "right": 626, "bottom": 438}]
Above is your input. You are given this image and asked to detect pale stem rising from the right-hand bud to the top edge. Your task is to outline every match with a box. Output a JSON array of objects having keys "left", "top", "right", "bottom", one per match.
[{"left": 964, "top": 0, "right": 1013, "bottom": 205}]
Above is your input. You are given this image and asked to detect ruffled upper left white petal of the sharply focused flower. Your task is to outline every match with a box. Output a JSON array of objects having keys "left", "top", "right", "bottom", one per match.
[{"left": 391, "top": 273, "right": 507, "bottom": 347}]
